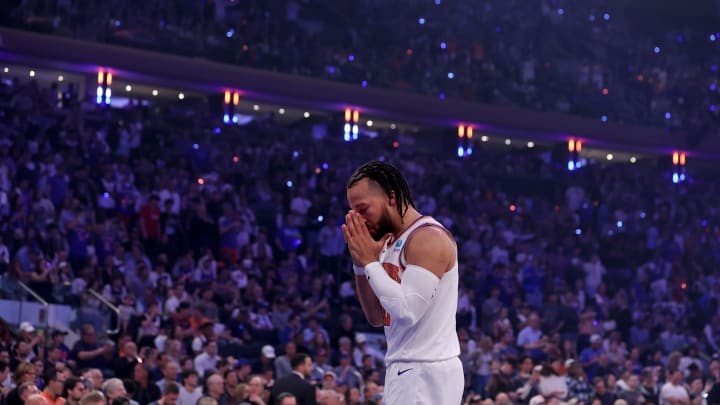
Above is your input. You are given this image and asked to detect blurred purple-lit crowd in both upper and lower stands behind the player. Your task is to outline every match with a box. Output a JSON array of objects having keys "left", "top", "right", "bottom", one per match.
[{"left": 0, "top": 0, "right": 720, "bottom": 405}]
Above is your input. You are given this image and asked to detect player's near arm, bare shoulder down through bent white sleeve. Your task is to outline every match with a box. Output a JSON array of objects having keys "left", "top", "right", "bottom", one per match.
[{"left": 365, "top": 226, "right": 455, "bottom": 325}]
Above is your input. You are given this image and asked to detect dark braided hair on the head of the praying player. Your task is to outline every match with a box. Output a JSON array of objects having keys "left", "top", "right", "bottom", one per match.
[{"left": 347, "top": 160, "right": 415, "bottom": 218}]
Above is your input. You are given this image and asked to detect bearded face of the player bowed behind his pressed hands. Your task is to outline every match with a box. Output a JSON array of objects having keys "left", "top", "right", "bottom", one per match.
[{"left": 347, "top": 179, "right": 395, "bottom": 240}]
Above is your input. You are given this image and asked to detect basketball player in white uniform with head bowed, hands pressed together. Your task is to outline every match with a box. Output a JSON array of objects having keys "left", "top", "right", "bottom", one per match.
[{"left": 342, "top": 161, "right": 464, "bottom": 405}]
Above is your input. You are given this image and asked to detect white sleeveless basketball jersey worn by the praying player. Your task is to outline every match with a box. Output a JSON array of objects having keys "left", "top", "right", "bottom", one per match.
[{"left": 380, "top": 216, "right": 460, "bottom": 365}]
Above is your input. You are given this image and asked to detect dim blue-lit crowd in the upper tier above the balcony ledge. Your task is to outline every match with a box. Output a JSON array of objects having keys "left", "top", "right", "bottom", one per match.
[{"left": 5, "top": 0, "right": 720, "bottom": 137}]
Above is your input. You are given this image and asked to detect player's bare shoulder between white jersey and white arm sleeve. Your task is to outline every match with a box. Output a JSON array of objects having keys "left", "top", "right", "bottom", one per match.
[{"left": 405, "top": 226, "right": 456, "bottom": 278}]
